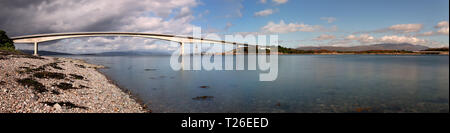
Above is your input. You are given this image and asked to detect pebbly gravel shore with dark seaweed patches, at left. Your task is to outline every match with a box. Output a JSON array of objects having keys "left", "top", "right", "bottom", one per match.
[{"left": 0, "top": 51, "right": 149, "bottom": 113}]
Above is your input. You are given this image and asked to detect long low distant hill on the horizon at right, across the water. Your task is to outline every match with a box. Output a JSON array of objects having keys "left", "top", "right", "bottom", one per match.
[{"left": 296, "top": 43, "right": 429, "bottom": 51}]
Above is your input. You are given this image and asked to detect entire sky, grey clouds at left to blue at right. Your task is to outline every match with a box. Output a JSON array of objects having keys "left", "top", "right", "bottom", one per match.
[{"left": 0, "top": 0, "right": 449, "bottom": 53}]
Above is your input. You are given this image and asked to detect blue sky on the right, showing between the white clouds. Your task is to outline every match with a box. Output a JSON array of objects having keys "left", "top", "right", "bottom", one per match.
[{"left": 192, "top": 0, "right": 449, "bottom": 47}]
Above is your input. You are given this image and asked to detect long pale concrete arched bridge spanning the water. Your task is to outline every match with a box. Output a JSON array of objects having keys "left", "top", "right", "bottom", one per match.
[{"left": 11, "top": 32, "right": 255, "bottom": 56}]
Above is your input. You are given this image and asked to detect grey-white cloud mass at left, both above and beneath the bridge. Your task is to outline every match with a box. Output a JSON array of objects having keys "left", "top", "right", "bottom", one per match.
[{"left": 0, "top": 0, "right": 198, "bottom": 52}]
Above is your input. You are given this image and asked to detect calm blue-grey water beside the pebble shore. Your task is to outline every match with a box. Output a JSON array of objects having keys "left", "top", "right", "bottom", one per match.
[{"left": 58, "top": 55, "right": 449, "bottom": 113}]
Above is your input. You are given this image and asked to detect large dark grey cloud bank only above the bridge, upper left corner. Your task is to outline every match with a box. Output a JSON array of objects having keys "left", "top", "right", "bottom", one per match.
[{"left": 0, "top": 0, "right": 197, "bottom": 35}]
